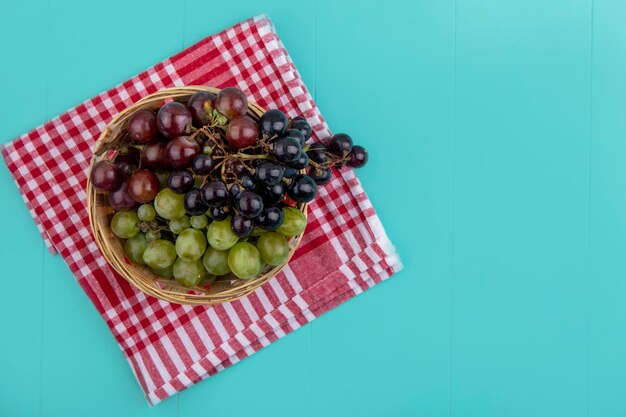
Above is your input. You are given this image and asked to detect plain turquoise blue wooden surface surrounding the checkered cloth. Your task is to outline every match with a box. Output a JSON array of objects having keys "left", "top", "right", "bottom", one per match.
[{"left": 0, "top": 0, "right": 626, "bottom": 417}]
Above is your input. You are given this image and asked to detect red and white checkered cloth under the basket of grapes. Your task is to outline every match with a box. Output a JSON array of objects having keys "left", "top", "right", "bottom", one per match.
[{"left": 2, "top": 16, "right": 401, "bottom": 404}]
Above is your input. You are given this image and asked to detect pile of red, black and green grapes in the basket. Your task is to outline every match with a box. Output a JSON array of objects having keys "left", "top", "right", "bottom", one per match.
[{"left": 90, "top": 87, "right": 368, "bottom": 287}]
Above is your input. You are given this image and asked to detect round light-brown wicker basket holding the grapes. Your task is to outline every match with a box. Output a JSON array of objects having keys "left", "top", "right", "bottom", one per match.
[{"left": 86, "top": 86, "right": 307, "bottom": 304}]
